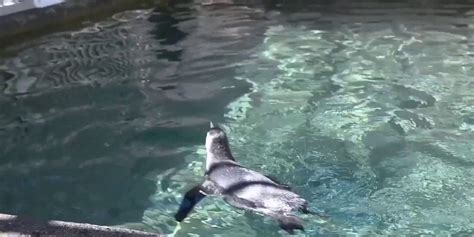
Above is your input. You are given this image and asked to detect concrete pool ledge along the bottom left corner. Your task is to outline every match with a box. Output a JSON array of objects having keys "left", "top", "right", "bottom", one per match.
[{"left": 0, "top": 214, "right": 165, "bottom": 237}]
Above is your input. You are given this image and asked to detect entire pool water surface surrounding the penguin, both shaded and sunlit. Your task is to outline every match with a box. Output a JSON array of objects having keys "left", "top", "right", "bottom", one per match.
[{"left": 0, "top": 1, "right": 474, "bottom": 236}]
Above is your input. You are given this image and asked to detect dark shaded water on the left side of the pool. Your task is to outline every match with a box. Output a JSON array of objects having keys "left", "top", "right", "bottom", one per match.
[{"left": 0, "top": 0, "right": 260, "bottom": 225}]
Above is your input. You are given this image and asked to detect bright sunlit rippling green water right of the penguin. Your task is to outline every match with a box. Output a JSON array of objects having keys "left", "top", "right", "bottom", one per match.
[{"left": 221, "top": 9, "right": 474, "bottom": 234}]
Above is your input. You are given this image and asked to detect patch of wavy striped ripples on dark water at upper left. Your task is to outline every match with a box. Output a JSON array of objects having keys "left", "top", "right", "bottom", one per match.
[{"left": 3, "top": 10, "right": 159, "bottom": 94}]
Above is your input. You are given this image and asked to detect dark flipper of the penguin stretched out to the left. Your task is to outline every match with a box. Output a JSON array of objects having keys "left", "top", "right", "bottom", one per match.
[{"left": 174, "top": 180, "right": 216, "bottom": 222}]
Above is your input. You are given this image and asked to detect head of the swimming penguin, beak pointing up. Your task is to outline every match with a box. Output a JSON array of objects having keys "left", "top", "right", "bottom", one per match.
[{"left": 206, "top": 122, "right": 233, "bottom": 159}]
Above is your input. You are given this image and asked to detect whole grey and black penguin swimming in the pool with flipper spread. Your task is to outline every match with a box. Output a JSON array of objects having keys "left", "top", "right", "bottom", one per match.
[{"left": 175, "top": 122, "right": 310, "bottom": 234}]
